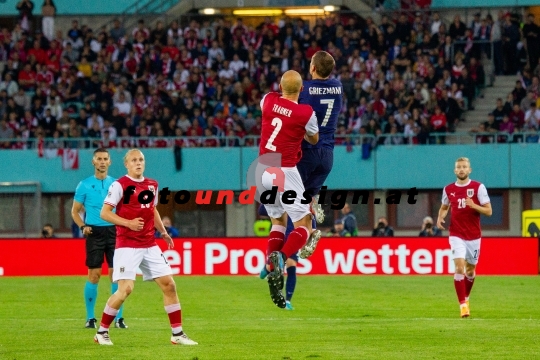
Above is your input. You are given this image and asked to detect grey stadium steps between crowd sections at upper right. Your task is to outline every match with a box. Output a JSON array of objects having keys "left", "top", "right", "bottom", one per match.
[{"left": 446, "top": 75, "right": 518, "bottom": 144}]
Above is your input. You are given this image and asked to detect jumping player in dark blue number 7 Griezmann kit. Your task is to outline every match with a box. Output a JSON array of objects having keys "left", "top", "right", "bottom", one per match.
[{"left": 259, "top": 51, "right": 344, "bottom": 310}]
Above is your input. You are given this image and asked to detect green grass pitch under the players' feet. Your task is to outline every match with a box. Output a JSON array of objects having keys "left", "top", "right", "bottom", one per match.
[{"left": 0, "top": 275, "right": 540, "bottom": 360}]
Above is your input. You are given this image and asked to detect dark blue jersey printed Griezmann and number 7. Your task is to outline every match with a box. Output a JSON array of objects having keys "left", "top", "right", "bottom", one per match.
[{"left": 298, "top": 79, "right": 343, "bottom": 149}]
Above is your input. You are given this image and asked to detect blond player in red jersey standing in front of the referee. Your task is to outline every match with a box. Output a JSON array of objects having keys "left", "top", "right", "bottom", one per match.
[{"left": 94, "top": 149, "right": 197, "bottom": 345}]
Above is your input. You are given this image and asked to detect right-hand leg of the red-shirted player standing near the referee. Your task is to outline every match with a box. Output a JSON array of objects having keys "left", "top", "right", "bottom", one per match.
[{"left": 155, "top": 275, "right": 197, "bottom": 345}]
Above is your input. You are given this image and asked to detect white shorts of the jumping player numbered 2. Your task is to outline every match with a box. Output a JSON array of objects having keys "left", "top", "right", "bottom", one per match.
[{"left": 262, "top": 166, "right": 311, "bottom": 223}]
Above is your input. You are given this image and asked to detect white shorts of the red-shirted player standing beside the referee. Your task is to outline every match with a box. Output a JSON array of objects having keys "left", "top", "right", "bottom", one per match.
[{"left": 113, "top": 245, "right": 172, "bottom": 282}]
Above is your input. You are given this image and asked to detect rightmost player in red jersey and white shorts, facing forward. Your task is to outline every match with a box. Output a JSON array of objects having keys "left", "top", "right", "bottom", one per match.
[{"left": 437, "top": 157, "right": 492, "bottom": 318}]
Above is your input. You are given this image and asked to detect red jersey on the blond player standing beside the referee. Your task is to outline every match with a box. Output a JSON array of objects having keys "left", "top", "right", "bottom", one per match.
[{"left": 104, "top": 175, "right": 158, "bottom": 249}]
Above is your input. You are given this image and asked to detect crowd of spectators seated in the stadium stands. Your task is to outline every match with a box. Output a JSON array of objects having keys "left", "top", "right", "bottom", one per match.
[{"left": 0, "top": 7, "right": 540, "bottom": 149}]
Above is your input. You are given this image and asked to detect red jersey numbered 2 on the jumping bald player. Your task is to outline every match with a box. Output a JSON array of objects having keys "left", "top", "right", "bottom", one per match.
[{"left": 259, "top": 92, "right": 319, "bottom": 167}]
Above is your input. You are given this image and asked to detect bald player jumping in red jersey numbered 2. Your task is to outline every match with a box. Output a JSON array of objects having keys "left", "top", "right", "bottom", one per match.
[{"left": 259, "top": 70, "right": 321, "bottom": 308}]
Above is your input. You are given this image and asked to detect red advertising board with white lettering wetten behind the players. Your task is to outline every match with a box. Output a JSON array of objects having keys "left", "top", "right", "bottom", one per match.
[{"left": 0, "top": 237, "right": 538, "bottom": 276}]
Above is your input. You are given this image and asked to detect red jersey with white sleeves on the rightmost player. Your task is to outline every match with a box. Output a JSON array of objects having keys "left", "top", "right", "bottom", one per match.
[{"left": 442, "top": 180, "right": 490, "bottom": 240}]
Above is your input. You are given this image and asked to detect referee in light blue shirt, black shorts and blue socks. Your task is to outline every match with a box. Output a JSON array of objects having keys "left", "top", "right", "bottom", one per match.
[{"left": 71, "top": 149, "right": 128, "bottom": 329}]
